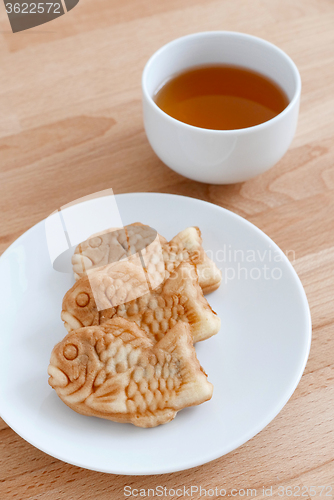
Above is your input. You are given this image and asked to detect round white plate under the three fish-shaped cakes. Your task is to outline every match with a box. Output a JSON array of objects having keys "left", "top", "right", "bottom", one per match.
[{"left": 0, "top": 193, "right": 311, "bottom": 474}]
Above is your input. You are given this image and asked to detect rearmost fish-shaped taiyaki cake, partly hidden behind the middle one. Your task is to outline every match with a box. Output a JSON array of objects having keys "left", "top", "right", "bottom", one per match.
[{"left": 72, "top": 223, "right": 221, "bottom": 294}]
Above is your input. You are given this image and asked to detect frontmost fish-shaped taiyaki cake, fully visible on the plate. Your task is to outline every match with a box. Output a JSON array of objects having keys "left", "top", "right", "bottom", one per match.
[{"left": 48, "top": 318, "right": 213, "bottom": 427}]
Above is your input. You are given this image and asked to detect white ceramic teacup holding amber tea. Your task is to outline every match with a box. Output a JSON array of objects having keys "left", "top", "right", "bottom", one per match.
[{"left": 142, "top": 31, "right": 301, "bottom": 184}]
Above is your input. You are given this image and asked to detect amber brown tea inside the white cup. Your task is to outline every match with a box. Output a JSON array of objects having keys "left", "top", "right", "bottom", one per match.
[{"left": 154, "top": 65, "right": 289, "bottom": 130}]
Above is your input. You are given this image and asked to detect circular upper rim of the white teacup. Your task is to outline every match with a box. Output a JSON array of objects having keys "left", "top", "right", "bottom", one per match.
[{"left": 141, "top": 30, "right": 301, "bottom": 135}]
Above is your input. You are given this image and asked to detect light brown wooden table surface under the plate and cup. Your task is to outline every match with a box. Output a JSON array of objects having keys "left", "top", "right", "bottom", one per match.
[{"left": 0, "top": 0, "right": 334, "bottom": 500}]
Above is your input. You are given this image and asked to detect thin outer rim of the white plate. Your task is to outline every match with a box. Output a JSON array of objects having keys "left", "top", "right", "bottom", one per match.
[{"left": 0, "top": 192, "right": 312, "bottom": 476}]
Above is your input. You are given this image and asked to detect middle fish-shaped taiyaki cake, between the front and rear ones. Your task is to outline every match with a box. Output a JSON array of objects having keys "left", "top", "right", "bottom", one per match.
[{"left": 61, "top": 262, "right": 220, "bottom": 342}]
